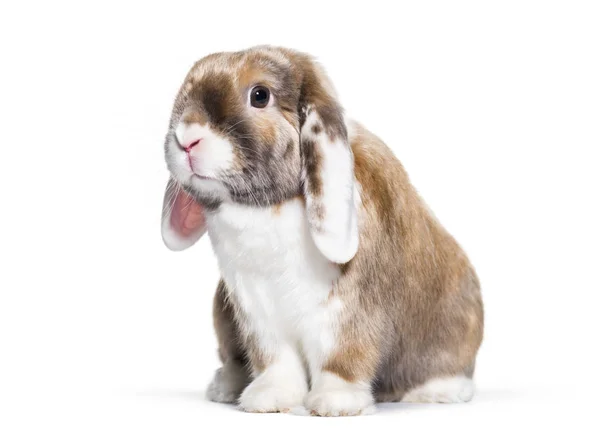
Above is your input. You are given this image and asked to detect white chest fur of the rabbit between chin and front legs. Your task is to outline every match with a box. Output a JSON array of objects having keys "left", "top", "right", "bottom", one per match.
[{"left": 207, "top": 199, "right": 341, "bottom": 367}]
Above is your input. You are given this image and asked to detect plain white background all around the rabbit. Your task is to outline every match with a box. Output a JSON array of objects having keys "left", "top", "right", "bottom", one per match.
[{"left": 0, "top": 0, "right": 600, "bottom": 435}]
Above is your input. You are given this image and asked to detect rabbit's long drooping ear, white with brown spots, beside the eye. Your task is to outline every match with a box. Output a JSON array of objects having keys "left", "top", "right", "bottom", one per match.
[{"left": 299, "top": 62, "right": 358, "bottom": 263}]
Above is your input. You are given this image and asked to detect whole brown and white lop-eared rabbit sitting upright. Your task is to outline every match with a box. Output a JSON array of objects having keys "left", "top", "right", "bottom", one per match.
[{"left": 161, "top": 46, "right": 483, "bottom": 416}]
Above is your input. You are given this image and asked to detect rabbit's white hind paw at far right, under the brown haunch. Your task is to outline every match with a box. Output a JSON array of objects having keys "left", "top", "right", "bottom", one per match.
[{"left": 402, "top": 376, "right": 475, "bottom": 403}]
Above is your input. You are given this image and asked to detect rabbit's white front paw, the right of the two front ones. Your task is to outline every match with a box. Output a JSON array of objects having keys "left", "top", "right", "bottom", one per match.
[{"left": 304, "top": 375, "right": 375, "bottom": 416}]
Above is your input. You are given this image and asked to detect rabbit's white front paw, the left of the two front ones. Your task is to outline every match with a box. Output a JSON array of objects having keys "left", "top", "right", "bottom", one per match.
[{"left": 240, "top": 376, "right": 307, "bottom": 413}]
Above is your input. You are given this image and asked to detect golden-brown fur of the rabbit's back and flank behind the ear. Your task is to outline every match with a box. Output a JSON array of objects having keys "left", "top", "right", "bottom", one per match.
[{"left": 328, "top": 126, "right": 483, "bottom": 401}]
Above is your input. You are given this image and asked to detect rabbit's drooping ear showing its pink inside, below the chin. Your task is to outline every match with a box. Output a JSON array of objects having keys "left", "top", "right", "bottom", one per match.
[{"left": 161, "top": 178, "right": 206, "bottom": 251}]
